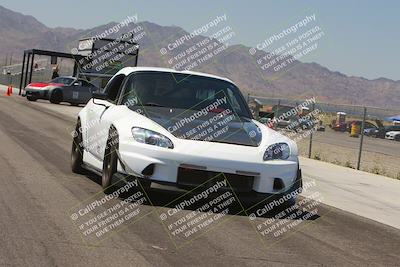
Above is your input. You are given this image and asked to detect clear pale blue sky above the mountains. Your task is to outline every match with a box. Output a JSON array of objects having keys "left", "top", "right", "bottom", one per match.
[{"left": 0, "top": 0, "right": 400, "bottom": 80}]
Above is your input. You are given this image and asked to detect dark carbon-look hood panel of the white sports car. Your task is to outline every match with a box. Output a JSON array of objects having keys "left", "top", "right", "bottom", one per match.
[{"left": 142, "top": 107, "right": 262, "bottom": 147}]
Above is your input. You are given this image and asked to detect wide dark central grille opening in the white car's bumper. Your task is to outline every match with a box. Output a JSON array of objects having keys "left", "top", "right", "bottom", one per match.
[{"left": 177, "top": 167, "right": 254, "bottom": 193}]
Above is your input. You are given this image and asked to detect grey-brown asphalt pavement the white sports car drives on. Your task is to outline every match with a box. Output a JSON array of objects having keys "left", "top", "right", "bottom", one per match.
[{"left": 0, "top": 96, "right": 400, "bottom": 266}]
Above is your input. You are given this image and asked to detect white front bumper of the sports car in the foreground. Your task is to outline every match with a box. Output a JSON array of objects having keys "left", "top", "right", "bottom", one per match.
[{"left": 118, "top": 140, "right": 301, "bottom": 194}]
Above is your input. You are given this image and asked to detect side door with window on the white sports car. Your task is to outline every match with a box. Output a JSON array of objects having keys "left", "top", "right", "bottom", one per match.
[{"left": 87, "top": 74, "right": 125, "bottom": 161}]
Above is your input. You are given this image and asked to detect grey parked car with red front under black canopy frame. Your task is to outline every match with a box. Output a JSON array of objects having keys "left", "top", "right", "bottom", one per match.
[{"left": 25, "top": 76, "right": 99, "bottom": 105}]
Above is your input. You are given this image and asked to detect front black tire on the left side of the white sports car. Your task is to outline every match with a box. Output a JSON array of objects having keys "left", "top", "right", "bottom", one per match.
[{"left": 101, "top": 127, "right": 118, "bottom": 194}]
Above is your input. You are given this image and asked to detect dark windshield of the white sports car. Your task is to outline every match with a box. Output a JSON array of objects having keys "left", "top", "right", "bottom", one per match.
[{"left": 122, "top": 72, "right": 251, "bottom": 118}]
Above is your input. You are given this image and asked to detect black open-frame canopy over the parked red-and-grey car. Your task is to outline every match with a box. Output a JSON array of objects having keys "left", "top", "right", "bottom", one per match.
[{"left": 19, "top": 49, "right": 83, "bottom": 95}]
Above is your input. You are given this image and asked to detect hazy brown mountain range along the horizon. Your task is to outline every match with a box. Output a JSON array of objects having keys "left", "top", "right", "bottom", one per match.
[{"left": 0, "top": 6, "right": 400, "bottom": 110}]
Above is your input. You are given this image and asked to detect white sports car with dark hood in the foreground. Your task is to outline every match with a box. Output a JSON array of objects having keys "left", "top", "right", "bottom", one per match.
[{"left": 71, "top": 67, "right": 302, "bottom": 203}]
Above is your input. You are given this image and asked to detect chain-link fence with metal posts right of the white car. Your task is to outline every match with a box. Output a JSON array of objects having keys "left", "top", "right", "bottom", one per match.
[{"left": 247, "top": 95, "right": 400, "bottom": 179}]
